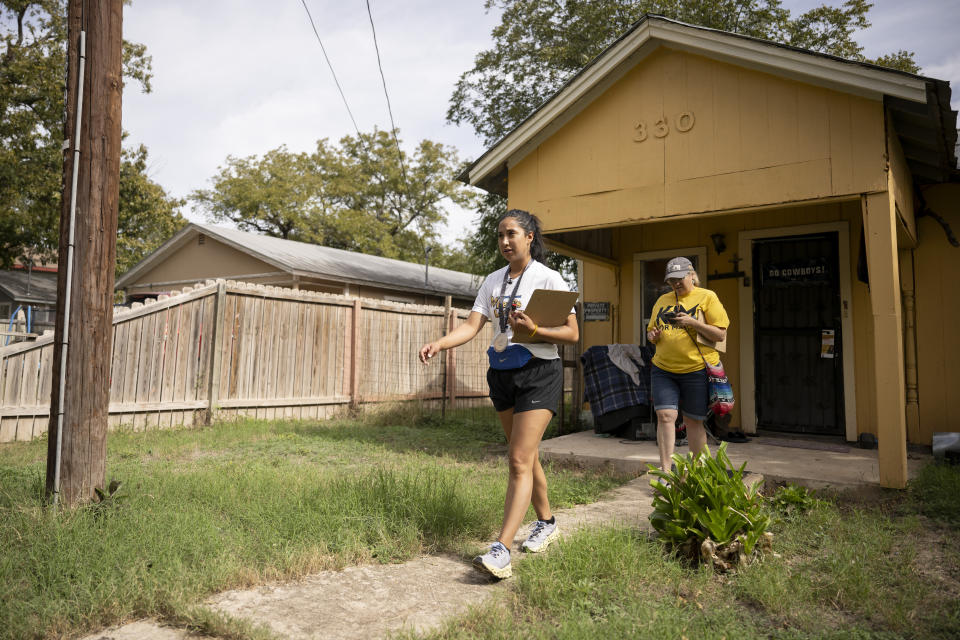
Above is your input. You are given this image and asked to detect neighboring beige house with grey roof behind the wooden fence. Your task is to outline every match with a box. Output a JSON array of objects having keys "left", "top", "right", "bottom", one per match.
[{"left": 116, "top": 223, "right": 480, "bottom": 307}]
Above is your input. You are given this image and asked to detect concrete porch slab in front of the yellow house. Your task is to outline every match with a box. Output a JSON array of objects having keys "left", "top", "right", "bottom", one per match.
[{"left": 540, "top": 431, "right": 930, "bottom": 490}]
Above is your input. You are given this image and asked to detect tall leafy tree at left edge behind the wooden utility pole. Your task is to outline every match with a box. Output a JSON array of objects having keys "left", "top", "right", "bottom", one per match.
[{"left": 0, "top": 0, "right": 151, "bottom": 268}]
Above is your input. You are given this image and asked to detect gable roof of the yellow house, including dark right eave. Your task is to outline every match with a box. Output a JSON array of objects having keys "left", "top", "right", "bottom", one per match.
[{"left": 458, "top": 14, "right": 957, "bottom": 196}]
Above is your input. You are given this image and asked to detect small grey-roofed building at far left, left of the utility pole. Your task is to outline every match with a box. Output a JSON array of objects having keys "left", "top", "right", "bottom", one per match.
[{"left": 0, "top": 265, "right": 57, "bottom": 338}]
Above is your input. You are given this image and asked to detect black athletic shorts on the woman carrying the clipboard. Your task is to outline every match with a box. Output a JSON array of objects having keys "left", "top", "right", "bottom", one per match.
[{"left": 487, "top": 358, "right": 563, "bottom": 415}]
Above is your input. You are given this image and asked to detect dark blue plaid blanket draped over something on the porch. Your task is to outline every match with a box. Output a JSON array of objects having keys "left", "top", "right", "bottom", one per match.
[{"left": 580, "top": 345, "right": 650, "bottom": 417}]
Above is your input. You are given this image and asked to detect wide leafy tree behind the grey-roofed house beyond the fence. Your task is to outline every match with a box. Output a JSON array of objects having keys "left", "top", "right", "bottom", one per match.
[{"left": 190, "top": 129, "right": 474, "bottom": 264}]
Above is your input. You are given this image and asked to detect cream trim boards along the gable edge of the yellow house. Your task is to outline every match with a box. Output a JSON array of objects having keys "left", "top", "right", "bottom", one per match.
[{"left": 468, "top": 17, "right": 927, "bottom": 185}]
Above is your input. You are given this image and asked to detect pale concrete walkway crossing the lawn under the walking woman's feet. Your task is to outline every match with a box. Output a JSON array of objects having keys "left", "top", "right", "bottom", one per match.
[{"left": 83, "top": 476, "right": 668, "bottom": 640}]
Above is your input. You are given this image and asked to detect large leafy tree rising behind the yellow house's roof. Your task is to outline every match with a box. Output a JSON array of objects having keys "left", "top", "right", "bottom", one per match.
[{"left": 447, "top": 0, "right": 919, "bottom": 268}]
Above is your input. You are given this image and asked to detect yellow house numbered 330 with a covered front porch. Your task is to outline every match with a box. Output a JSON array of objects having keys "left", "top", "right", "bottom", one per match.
[{"left": 461, "top": 16, "right": 960, "bottom": 487}]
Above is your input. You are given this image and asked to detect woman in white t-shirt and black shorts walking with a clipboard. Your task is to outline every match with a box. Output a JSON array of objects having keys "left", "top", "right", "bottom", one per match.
[{"left": 419, "top": 209, "right": 580, "bottom": 578}]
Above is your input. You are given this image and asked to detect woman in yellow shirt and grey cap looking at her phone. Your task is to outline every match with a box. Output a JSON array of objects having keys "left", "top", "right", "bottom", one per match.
[{"left": 647, "top": 257, "right": 730, "bottom": 471}]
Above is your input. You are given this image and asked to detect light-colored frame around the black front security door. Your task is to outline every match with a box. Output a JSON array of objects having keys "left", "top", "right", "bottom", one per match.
[{"left": 738, "top": 221, "right": 857, "bottom": 442}]
